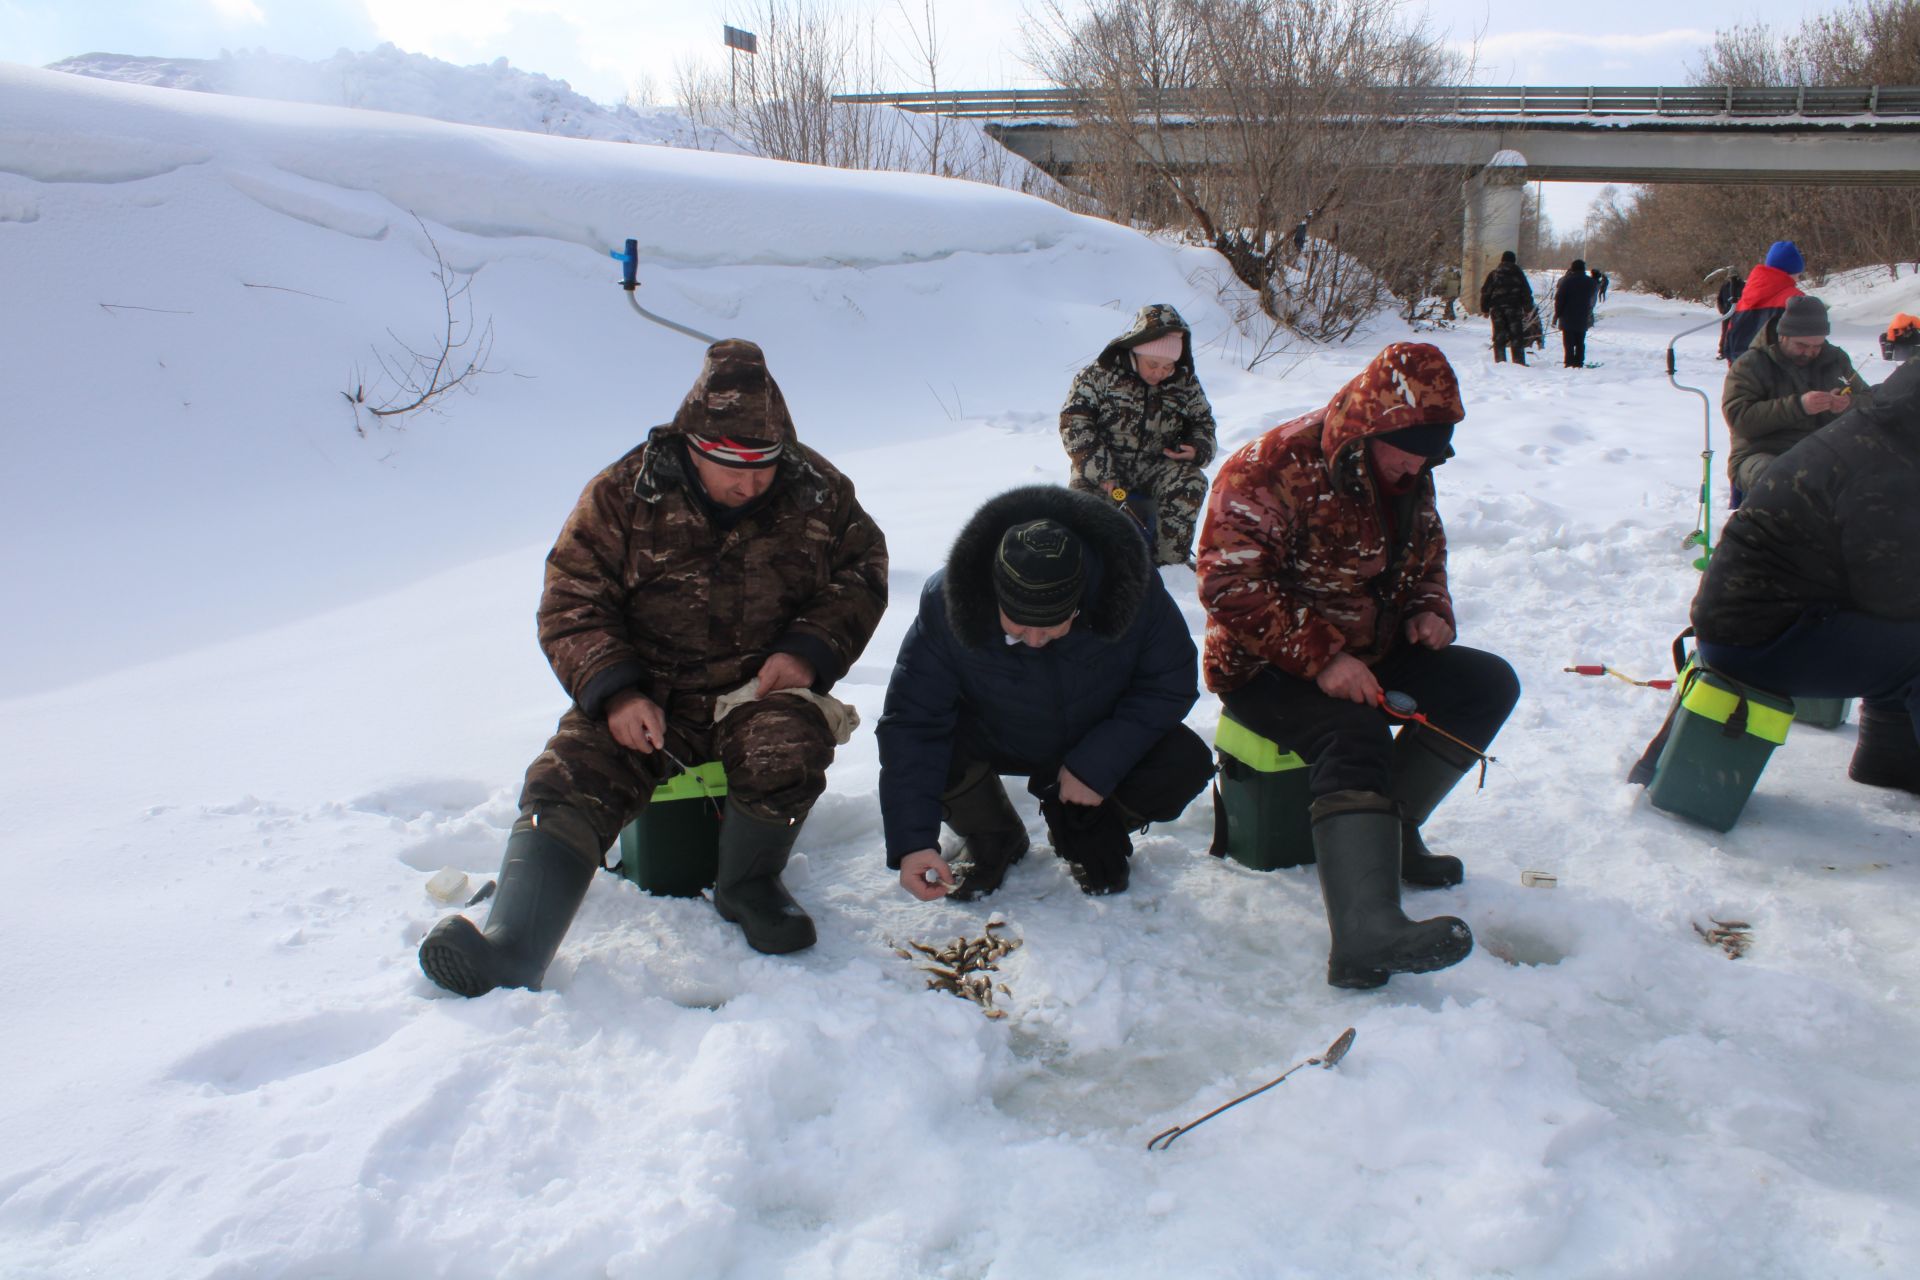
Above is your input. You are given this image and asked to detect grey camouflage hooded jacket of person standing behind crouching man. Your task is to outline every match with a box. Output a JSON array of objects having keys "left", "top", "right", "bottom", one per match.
[{"left": 1060, "top": 303, "right": 1217, "bottom": 493}]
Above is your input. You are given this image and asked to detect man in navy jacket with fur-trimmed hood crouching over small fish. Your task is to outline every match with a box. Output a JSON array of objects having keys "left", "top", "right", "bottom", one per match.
[{"left": 879, "top": 486, "right": 1213, "bottom": 902}]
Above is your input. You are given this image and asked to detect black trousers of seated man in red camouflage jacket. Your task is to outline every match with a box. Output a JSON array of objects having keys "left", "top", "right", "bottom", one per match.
[{"left": 1219, "top": 645, "right": 1521, "bottom": 796}]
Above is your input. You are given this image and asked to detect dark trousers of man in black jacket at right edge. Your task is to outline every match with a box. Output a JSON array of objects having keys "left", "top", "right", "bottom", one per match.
[{"left": 1699, "top": 610, "right": 1920, "bottom": 733}]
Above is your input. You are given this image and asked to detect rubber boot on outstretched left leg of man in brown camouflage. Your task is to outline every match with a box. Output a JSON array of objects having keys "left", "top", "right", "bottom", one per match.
[{"left": 420, "top": 814, "right": 599, "bottom": 996}]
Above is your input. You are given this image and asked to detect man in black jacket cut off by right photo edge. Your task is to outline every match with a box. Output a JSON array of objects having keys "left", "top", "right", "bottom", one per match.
[{"left": 1693, "top": 351, "right": 1920, "bottom": 793}]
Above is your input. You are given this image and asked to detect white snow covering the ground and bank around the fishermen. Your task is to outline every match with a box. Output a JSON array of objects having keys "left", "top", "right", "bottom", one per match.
[{"left": 0, "top": 67, "right": 1920, "bottom": 1278}]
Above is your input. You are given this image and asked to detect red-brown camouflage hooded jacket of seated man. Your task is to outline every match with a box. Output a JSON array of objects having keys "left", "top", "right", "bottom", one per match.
[{"left": 1200, "top": 342, "right": 1465, "bottom": 693}]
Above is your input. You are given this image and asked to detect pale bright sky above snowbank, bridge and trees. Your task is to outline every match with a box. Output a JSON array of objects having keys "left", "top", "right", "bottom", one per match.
[{"left": 0, "top": 0, "right": 1828, "bottom": 226}]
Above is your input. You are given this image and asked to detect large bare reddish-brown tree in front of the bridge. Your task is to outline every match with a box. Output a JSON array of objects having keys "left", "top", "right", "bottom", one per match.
[{"left": 1029, "top": 0, "right": 1463, "bottom": 340}]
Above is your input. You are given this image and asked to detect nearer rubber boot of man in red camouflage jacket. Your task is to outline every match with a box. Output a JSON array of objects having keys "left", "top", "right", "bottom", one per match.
[{"left": 1313, "top": 791, "right": 1473, "bottom": 988}]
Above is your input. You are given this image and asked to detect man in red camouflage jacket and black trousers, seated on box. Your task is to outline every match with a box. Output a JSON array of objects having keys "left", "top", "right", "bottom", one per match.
[{"left": 1200, "top": 342, "right": 1519, "bottom": 986}]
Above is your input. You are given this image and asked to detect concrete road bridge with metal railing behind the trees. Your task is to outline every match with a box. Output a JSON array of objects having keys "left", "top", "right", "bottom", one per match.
[{"left": 841, "top": 84, "right": 1920, "bottom": 305}]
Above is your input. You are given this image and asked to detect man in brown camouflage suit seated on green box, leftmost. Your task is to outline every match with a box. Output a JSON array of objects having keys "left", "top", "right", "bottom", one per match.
[{"left": 420, "top": 340, "right": 887, "bottom": 996}]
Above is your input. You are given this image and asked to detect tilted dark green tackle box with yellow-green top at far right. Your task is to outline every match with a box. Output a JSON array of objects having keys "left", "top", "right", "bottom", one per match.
[{"left": 1647, "top": 660, "right": 1793, "bottom": 831}]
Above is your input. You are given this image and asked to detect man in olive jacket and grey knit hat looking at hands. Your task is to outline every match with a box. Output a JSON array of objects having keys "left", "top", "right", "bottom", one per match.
[{"left": 1720, "top": 294, "right": 1872, "bottom": 495}]
